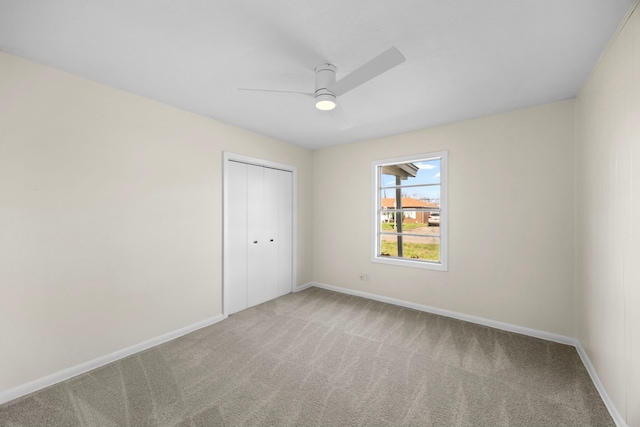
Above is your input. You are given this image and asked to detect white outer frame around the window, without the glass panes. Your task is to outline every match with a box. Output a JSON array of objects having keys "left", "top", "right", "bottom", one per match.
[{"left": 371, "top": 151, "right": 449, "bottom": 271}]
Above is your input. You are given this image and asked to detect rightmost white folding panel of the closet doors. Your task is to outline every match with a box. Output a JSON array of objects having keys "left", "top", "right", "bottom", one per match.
[{"left": 278, "top": 171, "right": 293, "bottom": 296}]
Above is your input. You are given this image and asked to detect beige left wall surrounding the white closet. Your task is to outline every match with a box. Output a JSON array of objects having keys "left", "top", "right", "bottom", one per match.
[{"left": 0, "top": 54, "right": 312, "bottom": 393}]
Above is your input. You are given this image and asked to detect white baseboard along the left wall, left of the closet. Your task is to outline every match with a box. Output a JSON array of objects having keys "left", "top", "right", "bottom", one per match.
[{"left": 0, "top": 314, "right": 224, "bottom": 404}]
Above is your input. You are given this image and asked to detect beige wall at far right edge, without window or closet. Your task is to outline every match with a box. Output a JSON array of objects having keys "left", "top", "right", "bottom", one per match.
[{"left": 576, "top": 4, "right": 640, "bottom": 427}]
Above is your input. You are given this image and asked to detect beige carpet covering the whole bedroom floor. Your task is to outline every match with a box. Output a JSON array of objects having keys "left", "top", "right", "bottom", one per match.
[{"left": 0, "top": 288, "right": 614, "bottom": 427}]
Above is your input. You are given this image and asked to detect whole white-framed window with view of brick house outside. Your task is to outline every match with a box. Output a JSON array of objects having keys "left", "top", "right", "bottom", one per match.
[{"left": 371, "top": 151, "right": 447, "bottom": 271}]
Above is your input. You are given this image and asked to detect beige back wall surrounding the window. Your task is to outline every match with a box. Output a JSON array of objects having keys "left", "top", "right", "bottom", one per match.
[{"left": 313, "top": 101, "right": 575, "bottom": 336}]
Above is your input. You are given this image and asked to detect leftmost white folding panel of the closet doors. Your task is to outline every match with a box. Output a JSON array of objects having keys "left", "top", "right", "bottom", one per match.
[{"left": 224, "top": 162, "right": 247, "bottom": 314}]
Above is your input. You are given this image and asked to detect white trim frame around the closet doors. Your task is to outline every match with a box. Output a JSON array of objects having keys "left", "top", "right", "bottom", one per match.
[{"left": 222, "top": 151, "right": 298, "bottom": 318}]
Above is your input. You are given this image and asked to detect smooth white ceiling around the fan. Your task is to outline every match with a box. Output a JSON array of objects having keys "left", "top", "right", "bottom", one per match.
[{"left": 0, "top": 0, "right": 634, "bottom": 149}]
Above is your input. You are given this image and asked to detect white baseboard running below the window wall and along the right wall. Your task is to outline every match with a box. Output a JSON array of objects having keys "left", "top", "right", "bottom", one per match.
[{"left": 308, "top": 282, "right": 627, "bottom": 427}]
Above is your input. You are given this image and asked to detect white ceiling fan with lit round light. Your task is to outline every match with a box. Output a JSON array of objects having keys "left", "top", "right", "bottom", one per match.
[{"left": 239, "top": 47, "right": 405, "bottom": 128}]
